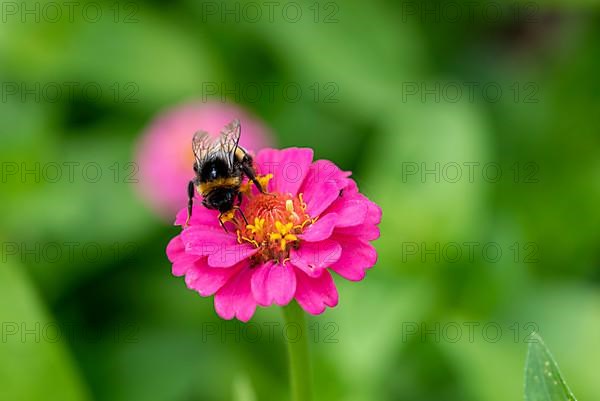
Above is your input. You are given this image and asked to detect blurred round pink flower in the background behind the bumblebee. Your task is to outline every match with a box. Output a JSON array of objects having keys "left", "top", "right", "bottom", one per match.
[{"left": 137, "top": 102, "right": 273, "bottom": 218}]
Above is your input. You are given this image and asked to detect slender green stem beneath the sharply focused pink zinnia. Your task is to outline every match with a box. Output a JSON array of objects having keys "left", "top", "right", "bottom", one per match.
[{"left": 283, "top": 301, "right": 312, "bottom": 401}]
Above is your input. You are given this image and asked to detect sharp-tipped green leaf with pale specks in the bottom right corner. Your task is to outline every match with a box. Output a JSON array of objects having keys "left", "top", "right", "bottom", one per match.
[{"left": 525, "top": 334, "right": 576, "bottom": 401}]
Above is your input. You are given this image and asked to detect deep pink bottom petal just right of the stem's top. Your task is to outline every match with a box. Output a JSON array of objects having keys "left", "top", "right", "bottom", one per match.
[{"left": 295, "top": 270, "right": 338, "bottom": 315}]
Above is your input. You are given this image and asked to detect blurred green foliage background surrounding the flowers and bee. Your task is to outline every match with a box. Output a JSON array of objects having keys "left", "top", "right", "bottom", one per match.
[{"left": 0, "top": 0, "right": 600, "bottom": 401}]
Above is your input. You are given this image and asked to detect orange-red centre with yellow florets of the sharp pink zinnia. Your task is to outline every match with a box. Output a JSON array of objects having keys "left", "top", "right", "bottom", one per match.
[{"left": 234, "top": 174, "right": 313, "bottom": 264}]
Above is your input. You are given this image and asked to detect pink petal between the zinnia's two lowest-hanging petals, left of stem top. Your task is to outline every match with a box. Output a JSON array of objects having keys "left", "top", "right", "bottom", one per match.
[{"left": 251, "top": 262, "right": 296, "bottom": 306}]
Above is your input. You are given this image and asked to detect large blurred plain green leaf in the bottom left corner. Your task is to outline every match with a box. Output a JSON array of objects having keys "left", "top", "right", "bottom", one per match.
[{"left": 0, "top": 262, "right": 90, "bottom": 401}]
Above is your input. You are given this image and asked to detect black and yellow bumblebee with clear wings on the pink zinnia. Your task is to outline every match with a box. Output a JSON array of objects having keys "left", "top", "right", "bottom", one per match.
[{"left": 186, "top": 120, "right": 265, "bottom": 231}]
